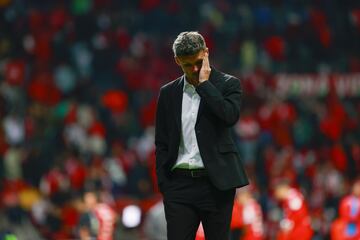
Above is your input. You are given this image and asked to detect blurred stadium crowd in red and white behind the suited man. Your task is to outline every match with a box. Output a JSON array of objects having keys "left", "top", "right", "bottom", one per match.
[{"left": 0, "top": 0, "right": 360, "bottom": 240}]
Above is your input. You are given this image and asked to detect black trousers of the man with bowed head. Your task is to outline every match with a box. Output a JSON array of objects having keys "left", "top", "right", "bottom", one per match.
[{"left": 164, "top": 174, "right": 235, "bottom": 240}]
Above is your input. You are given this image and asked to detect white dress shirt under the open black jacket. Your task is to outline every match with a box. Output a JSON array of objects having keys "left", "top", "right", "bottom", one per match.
[{"left": 174, "top": 79, "right": 204, "bottom": 169}]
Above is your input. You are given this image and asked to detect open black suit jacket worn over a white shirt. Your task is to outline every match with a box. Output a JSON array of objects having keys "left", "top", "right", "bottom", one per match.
[{"left": 155, "top": 68, "right": 248, "bottom": 192}]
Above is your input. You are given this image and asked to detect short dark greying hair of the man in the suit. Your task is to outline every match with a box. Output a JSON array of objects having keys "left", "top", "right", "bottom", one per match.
[{"left": 173, "top": 32, "right": 206, "bottom": 57}]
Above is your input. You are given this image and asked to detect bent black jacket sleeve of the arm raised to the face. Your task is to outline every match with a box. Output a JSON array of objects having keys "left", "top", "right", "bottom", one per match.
[{"left": 196, "top": 77, "right": 242, "bottom": 127}]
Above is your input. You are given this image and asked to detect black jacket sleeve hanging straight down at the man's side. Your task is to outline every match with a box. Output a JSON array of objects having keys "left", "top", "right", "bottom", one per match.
[{"left": 155, "top": 88, "right": 169, "bottom": 189}]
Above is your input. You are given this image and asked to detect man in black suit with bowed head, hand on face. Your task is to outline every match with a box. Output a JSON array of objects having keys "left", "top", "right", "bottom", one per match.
[{"left": 155, "top": 32, "right": 248, "bottom": 240}]
